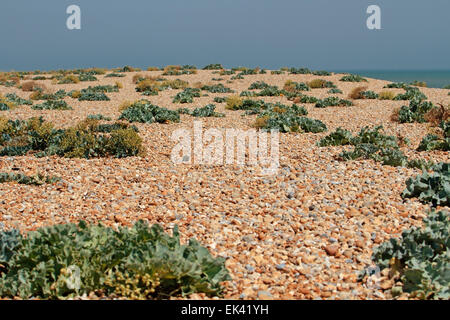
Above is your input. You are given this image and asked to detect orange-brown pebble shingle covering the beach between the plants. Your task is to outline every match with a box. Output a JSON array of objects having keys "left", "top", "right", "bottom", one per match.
[{"left": 0, "top": 71, "right": 450, "bottom": 299}]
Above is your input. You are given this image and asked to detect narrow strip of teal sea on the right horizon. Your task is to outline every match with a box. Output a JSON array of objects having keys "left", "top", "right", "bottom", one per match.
[{"left": 335, "top": 70, "right": 450, "bottom": 88}]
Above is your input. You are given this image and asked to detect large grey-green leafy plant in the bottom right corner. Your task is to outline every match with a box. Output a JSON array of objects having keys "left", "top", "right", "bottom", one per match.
[{"left": 372, "top": 211, "right": 450, "bottom": 300}]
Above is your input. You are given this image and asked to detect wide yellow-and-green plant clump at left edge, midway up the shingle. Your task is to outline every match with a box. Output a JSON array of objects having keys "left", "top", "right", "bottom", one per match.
[{"left": 0, "top": 117, "right": 145, "bottom": 159}]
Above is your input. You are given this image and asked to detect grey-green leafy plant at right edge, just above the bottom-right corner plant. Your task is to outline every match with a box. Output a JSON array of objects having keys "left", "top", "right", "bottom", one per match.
[{"left": 402, "top": 162, "right": 450, "bottom": 206}]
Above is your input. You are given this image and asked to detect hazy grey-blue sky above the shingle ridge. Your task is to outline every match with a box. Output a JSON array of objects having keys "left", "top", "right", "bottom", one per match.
[{"left": 0, "top": 0, "right": 450, "bottom": 70}]
